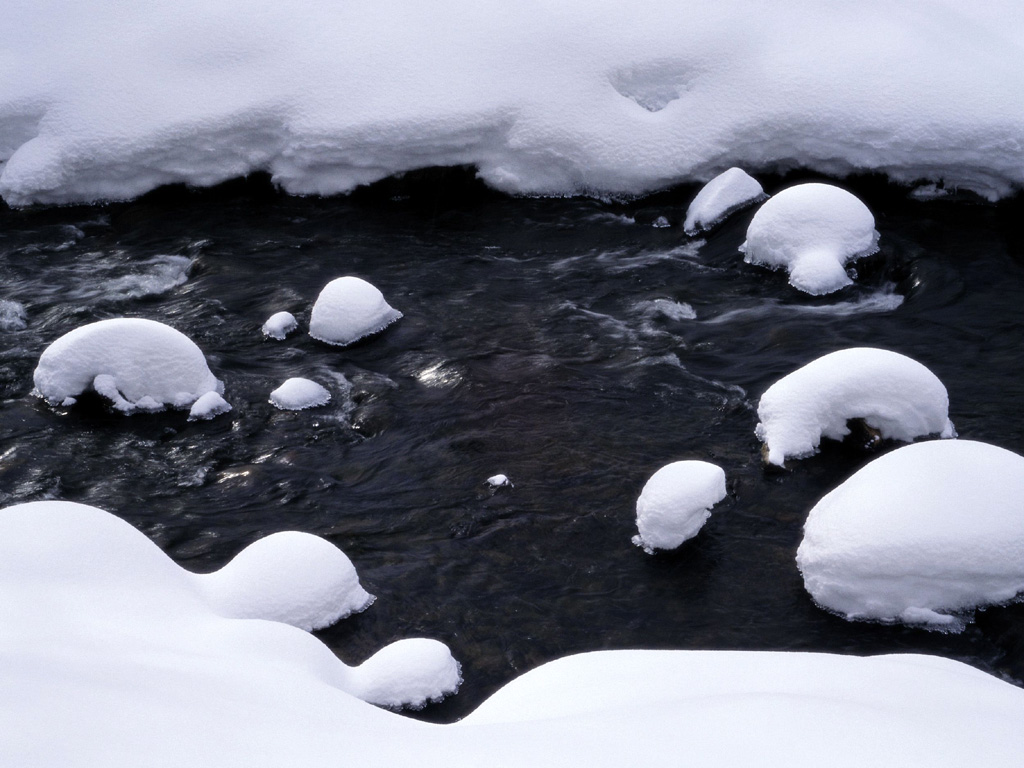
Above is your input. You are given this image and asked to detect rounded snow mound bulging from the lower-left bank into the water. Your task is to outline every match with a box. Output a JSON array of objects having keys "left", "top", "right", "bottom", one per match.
[{"left": 197, "top": 530, "right": 374, "bottom": 630}]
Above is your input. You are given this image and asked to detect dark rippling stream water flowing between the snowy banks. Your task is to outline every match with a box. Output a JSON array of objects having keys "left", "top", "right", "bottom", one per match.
[{"left": 0, "top": 172, "right": 1024, "bottom": 720}]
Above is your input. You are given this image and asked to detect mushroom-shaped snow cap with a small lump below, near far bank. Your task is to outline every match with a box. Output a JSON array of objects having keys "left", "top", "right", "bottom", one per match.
[{"left": 739, "top": 183, "right": 879, "bottom": 296}]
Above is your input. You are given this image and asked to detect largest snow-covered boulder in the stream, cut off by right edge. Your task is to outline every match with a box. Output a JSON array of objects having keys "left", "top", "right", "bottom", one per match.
[{"left": 797, "top": 440, "right": 1024, "bottom": 631}]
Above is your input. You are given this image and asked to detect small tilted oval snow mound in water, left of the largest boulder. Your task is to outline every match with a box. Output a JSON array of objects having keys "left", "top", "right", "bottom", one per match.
[{"left": 633, "top": 461, "right": 726, "bottom": 554}]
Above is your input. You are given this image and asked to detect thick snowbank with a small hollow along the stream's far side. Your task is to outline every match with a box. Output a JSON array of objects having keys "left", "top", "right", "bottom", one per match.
[{"left": 0, "top": 0, "right": 1024, "bottom": 206}]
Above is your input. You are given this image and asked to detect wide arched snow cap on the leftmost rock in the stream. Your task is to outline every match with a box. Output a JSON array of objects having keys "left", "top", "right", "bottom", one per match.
[{"left": 34, "top": 317, "right": 224, "bottom": 414}]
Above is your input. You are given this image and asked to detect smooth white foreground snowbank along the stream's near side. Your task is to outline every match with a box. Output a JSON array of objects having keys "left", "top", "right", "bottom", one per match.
[{"left": 0, "top": 502, "right": 1024, "bottom": 768}]
